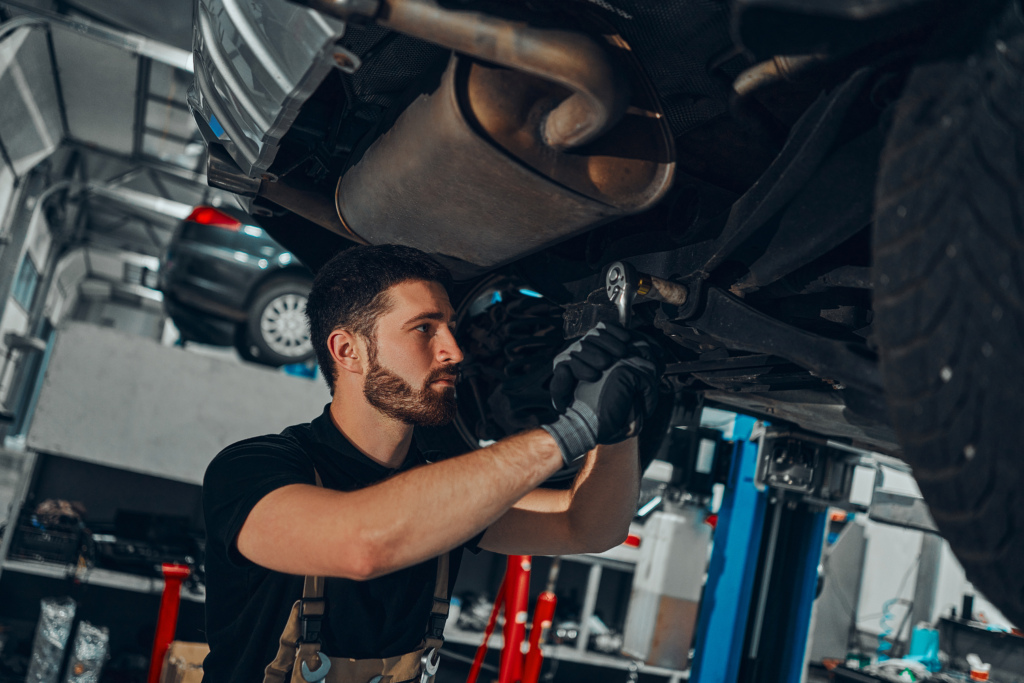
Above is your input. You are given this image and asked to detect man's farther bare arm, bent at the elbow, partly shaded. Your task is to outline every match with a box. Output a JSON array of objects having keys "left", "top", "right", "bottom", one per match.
[{"left": 480, "top": 438, "right": 640, "bottom": 555}]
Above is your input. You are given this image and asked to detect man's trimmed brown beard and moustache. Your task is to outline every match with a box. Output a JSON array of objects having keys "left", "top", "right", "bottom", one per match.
[{"left": 362, "top": 342, "right": 458, "bottom": 427}]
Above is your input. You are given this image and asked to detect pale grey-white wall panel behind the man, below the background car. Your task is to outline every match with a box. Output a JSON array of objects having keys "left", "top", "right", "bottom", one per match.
[{"left": 28, "top": 323, "right": 331, "bottom": 483}]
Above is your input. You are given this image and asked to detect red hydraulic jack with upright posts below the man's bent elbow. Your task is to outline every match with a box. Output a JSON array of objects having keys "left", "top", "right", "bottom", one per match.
[{"left": 466, "top": 555, "right": 559, "bottom": 683}]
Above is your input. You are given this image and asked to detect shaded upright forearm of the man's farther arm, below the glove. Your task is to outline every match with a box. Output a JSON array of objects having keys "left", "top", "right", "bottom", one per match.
[{"left": 567, "top": 438, "right": 640, "bottom": 552}]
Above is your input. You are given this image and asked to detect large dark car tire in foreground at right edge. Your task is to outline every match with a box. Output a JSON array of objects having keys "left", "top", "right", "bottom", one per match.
[{"left": 873, "top": 3, "right": 1024, "bottom": 626}]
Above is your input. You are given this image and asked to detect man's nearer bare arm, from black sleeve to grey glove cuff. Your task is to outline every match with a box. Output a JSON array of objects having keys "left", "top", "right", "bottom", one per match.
[{"left": 237, "top": 429, "right": 562, "bottom": 580}]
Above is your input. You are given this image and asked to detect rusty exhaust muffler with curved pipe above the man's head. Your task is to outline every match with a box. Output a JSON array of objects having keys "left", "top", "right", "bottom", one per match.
[{"left": 292, "top": 0, "right": 675, "bottom": 278}]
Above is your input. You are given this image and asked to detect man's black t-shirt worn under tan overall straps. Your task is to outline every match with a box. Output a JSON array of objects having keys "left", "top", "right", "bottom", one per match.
[{"left": 203, "top": 405, "right": 482, "bottom": 683}]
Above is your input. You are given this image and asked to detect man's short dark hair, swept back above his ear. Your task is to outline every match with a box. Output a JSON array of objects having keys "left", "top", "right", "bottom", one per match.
[{"left": 306, "top": 245, "right": 453, "bottom": 394}]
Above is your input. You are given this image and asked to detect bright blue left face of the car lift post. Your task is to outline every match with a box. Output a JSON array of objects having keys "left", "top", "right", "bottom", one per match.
[{"left": 690, "top": 432, "right": 767, "bottom": 683}]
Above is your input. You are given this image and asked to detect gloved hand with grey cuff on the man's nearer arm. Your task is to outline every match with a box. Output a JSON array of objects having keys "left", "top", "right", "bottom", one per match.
[{"left": 543, "top": 325, "right": 664, "bottom": 466}]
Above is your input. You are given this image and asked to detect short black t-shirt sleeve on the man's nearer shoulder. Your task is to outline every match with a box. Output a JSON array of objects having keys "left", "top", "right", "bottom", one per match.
[{"left": 203, "top": 436, "right": 316, "bottom": 567}]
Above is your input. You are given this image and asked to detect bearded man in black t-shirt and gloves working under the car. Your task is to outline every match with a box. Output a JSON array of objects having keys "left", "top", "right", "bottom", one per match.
[{"left": 203, "top": 246, "right": 659, "bottom": 683}]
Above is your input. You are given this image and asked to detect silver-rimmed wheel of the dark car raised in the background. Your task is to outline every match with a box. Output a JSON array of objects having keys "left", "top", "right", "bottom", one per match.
[{"left": 237, "top": 276, "right": 313, "bottom": 368}]
